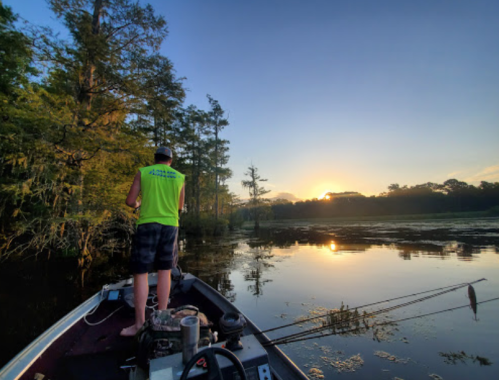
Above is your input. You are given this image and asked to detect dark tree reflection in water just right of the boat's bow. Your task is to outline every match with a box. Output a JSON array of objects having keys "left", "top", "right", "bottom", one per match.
[{"left": 179, "top": 238, "right": 238, "bottom": 302}]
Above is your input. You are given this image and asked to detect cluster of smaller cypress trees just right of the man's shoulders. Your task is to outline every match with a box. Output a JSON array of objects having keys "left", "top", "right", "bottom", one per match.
[{"left": 169, "top": 97, "right": 234, "bottom": 235}]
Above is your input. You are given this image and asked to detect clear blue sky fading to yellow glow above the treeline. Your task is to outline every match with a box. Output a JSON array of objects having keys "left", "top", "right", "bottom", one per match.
[{"left": 4, "top": 0, "right": 499, "bottom": 199}]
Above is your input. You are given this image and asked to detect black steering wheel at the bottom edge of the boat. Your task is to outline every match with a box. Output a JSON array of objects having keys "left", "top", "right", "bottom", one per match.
[{"left": 180, "top": 347, "right": 248, "bottom": 380}]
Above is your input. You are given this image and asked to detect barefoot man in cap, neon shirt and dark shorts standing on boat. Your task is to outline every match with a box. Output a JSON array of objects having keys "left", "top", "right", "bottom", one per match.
[{"left": 121, "top": 147, "right": 185, "bottom": 336}]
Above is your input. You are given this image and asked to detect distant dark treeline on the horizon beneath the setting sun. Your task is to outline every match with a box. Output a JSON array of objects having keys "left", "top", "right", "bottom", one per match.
[{"left": 272, "top": 179, "right": 499, "bottom": 219}]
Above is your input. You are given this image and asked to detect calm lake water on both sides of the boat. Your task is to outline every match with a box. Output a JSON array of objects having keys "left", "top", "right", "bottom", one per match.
[{"left": 0, "top": 218, "right": 499, "bottom": 379}]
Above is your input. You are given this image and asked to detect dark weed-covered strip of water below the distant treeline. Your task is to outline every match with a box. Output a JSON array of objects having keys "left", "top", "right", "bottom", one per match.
[{"left": 250, "top": 218, "right": 499, "bottom": 260}]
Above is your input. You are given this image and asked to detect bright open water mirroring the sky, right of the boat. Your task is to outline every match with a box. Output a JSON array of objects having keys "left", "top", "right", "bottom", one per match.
[{"left": 213, "top": 244, "right": 499, "bottom": 379}]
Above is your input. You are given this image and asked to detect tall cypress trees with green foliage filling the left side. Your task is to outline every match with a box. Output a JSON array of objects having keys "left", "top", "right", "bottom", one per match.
[{"left": 0, "top": 0, "right": 231, "bottom": 268}]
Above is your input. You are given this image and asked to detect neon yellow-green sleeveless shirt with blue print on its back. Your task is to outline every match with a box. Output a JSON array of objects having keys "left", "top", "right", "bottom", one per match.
[{"left": 137, "top": 164, "right": 185, "bottom": 226}]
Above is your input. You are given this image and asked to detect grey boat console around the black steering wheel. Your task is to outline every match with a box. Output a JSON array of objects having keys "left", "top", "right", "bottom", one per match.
[{"left": 149, "top": 335, "right": 272, "bottom": 380}]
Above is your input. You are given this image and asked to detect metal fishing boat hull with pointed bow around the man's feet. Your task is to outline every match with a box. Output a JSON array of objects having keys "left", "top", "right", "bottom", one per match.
[{"left": 0, "top": 274, "right": 307, "bottom": 380}]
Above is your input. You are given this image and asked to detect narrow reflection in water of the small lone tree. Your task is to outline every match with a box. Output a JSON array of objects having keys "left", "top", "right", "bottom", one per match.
[{"left": 244, "top": 241, "right": 274, "bottom": 297}]
